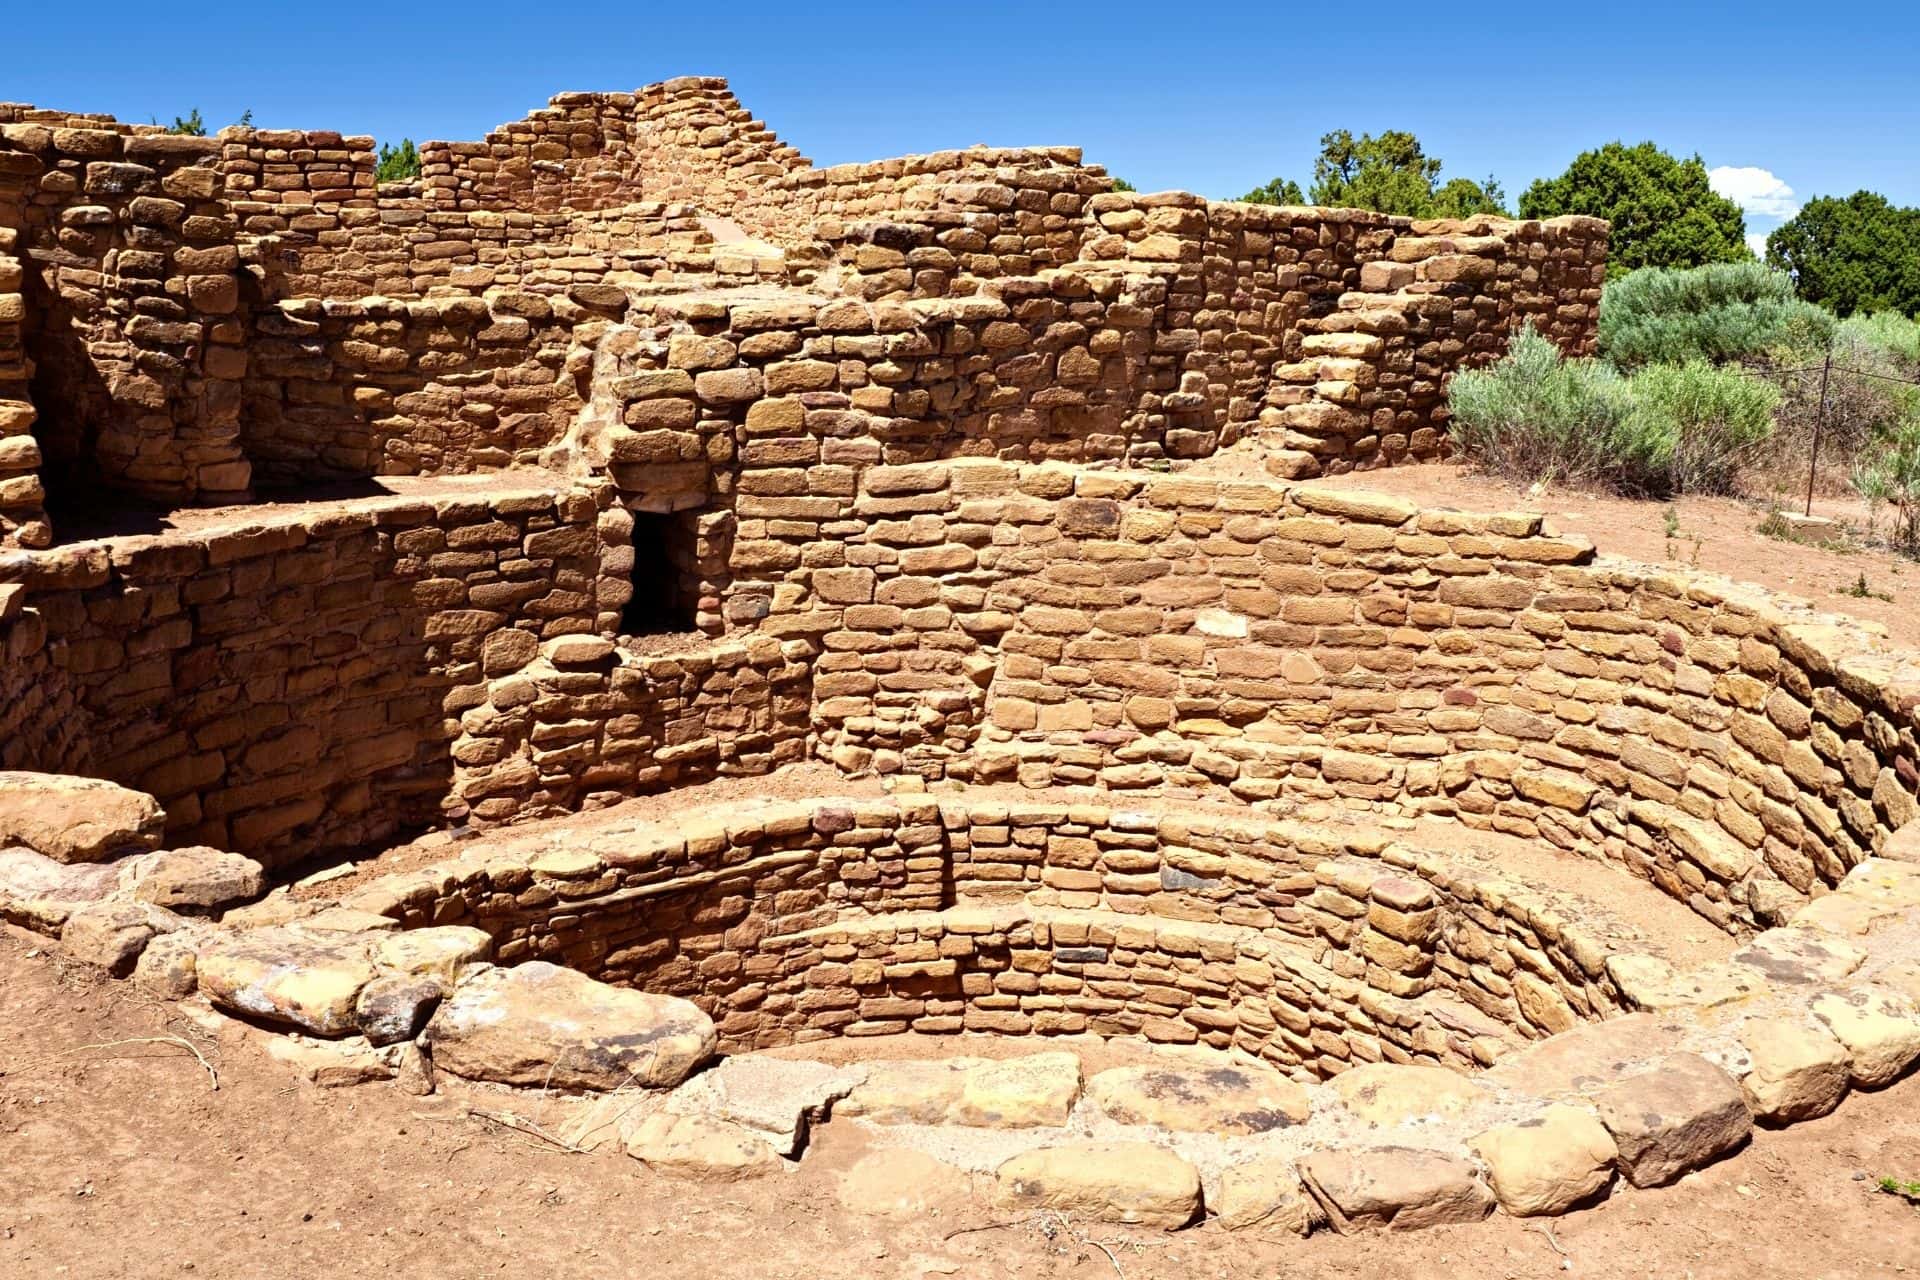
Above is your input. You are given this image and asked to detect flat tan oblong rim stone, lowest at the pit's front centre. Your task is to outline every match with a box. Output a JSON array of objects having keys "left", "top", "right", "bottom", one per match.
[{"left": 993, "top": 1142, "right": 1200, "bottom": 1230}]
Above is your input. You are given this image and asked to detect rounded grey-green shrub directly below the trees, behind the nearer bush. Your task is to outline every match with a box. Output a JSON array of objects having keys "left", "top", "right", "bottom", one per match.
[{"left": 1599, "top": 261, "right": 1834, "bottom": 368}]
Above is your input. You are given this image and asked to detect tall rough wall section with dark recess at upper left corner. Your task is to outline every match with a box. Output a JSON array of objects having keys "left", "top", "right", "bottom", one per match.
[{"left": 0, "top": 121, "right": 250, "bottom": 503}]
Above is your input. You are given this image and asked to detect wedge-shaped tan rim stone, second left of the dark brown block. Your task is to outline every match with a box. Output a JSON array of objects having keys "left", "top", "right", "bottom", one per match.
[{"left": 1300, "top": 1148, "right": 1494, "bottom": 1234}]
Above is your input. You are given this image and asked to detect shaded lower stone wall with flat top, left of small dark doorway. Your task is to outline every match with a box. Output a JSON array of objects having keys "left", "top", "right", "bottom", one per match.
[{"left": 0, "top": 486, "right": 630, "bottom": 865}]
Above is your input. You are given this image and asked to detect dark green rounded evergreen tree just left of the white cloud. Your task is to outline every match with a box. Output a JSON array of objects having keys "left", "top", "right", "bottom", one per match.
[{"left": 1521, "top": 142, "right": 1751, "bottom": 276}]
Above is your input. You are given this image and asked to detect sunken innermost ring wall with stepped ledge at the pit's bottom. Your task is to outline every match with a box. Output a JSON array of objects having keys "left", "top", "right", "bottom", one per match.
[{"left": 346, "top": 796, "right": 1732, "bottom": 1075}]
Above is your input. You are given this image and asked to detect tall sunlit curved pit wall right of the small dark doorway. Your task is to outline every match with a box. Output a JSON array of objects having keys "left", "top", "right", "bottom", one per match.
[{"left": 691, "top": 462, "right": 1920, "bottom": 923}]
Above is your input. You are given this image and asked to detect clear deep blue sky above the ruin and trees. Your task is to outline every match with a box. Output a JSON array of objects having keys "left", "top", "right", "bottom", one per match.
[{"left": 0, "top": 0, "right": 1920, "bottom": 249}]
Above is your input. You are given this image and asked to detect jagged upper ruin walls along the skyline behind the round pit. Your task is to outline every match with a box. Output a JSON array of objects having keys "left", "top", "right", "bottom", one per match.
[{"left": 0, "top": 79, "right": 1603, "bottom": 543}]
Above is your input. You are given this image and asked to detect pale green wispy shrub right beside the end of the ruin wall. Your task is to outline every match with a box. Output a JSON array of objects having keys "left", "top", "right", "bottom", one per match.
[{"left": 1448, "top": 324, "right": 1778, "bottom": 497}]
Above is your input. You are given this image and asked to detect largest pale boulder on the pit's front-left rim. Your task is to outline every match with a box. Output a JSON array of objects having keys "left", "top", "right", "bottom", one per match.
[{"left": 424, "top": 961, "right": 716, "bottom": 1090}]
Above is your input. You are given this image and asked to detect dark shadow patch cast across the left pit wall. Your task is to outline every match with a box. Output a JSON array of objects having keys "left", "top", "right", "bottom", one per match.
[{"left": 21, "top": 518, "right": 466, "bottom": 865}]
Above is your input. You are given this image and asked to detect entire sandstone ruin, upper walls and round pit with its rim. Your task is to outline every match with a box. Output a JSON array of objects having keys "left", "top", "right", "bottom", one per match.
[{"left": 0, "top": 77, "right": 1920, "bottom": 1234}]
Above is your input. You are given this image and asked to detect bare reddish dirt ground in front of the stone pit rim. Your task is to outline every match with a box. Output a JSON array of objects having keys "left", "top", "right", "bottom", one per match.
[{"left": 0, "top": 931, "right": 1920, "bottom": 1280}]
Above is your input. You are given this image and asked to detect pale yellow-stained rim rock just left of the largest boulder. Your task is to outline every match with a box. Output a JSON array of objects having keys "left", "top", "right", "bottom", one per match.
[{"left": 196, "top": 925, "right": 374, "bottom": 1038}]
